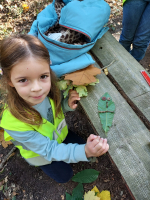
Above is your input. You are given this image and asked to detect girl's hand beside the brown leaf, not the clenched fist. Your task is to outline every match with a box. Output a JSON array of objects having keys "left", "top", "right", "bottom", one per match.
[{"left": 68, "top": 90, "right": 80, "bottom": 109}]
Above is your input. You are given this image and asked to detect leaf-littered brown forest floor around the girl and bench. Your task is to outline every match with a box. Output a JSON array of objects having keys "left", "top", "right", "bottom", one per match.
[{"left": 0, "top": 0, "right": 150, "bottom": 200}]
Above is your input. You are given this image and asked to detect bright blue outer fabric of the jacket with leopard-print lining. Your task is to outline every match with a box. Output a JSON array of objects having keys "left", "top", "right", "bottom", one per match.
[{"left": 29, "top": 0, "right": 110, "bottom": 76}]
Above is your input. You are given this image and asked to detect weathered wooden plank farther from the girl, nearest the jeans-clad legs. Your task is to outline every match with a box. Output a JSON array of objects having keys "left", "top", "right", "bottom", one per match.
[{"left": 92, "top": 32, "right": 150, "bottom": 122}]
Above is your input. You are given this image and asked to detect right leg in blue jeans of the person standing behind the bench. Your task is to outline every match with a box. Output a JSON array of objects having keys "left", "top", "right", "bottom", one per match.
[{"left": 131, "top": 1, "right": 150, "bottom": 61}]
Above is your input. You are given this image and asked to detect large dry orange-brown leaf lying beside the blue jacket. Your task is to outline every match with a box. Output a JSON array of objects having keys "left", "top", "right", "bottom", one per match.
[{"left": 64, "top": 65, "right": 101, "bottom": 85}]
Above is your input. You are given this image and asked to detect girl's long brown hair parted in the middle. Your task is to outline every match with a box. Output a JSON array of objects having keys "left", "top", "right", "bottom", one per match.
[{"left": 0, "top": 35, "right": 62, "bottom": 125}]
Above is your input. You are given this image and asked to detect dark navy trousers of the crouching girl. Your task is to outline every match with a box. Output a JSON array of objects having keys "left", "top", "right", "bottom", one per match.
[{"left": 40, "top": 130, "right": 85, "bottom": 183}]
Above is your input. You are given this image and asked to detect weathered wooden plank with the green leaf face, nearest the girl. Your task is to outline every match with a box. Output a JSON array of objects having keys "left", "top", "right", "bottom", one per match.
[{"left": 80, "top": 61, "right": 150, "bottom": 200}]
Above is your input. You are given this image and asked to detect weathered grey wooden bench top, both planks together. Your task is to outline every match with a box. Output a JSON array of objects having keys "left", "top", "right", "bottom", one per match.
[{"left": 80, "top": 32, "right": 150, "bottom": 200}]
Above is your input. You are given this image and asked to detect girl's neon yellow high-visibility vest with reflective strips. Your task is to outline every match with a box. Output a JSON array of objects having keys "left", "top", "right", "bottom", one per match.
[{"left": 0, "top": 99, "right": 68, "bottom": 159}]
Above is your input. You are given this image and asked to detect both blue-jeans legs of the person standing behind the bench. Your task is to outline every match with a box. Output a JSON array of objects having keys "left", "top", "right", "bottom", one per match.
[{"left": 119, "top": 0, "right": 150, "bottom": 61}]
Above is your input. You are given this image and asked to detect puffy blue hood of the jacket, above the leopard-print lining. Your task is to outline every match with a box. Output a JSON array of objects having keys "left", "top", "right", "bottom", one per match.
[{"left": 59, "top": 0, "right": 110, "bottom": 42}]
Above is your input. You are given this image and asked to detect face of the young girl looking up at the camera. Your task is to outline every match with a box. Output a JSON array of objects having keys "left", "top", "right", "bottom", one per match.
[{"left": 9, "top": 57, "right": 51, "bottom": 106}]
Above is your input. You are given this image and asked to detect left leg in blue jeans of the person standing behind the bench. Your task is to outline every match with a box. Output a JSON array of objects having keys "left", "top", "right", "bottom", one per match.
[{"left": 119, "top": 0, "right": 147, "bottom": 52}]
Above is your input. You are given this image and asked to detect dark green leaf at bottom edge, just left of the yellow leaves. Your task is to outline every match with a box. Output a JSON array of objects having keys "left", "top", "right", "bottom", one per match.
[{"left": 71, "top": 183, "right": 84, "bottom": 200}]
